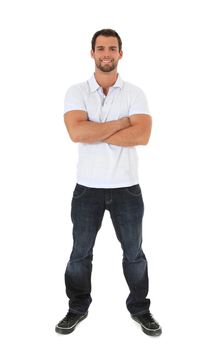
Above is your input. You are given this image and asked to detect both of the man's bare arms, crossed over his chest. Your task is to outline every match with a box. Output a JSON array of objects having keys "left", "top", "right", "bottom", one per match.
[{"left": 64, "top": 110, "right": 152, "bottom": 147}]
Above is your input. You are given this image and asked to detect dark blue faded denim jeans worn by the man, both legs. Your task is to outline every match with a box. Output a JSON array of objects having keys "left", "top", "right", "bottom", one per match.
[{"left": 65, "top": 184, "right": 150, "bottom": 315}]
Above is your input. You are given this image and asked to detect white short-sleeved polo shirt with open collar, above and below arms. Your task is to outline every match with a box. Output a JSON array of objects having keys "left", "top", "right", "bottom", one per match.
[{"left": 64, "top": 74, "right": 150, "bottom": 188}]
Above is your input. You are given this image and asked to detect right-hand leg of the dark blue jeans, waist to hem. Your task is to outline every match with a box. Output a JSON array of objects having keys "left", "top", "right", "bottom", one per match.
[{"left": 110, "top": 185, "right": 150, "bottom": 315}]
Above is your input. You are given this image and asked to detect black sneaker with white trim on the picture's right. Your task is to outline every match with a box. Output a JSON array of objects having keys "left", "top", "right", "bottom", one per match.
[{"left": 131, "top": 312, "right": 162, "bottom": 336}]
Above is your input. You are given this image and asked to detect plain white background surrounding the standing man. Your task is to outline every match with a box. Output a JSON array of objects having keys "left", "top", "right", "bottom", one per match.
[{"left": 0, "top": 0, "right": 220, "bottom": 350}]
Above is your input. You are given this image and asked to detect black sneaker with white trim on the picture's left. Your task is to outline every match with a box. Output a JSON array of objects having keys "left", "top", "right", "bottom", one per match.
[{"left": 55, "top": 311, "right": 88, "bottom": 334}]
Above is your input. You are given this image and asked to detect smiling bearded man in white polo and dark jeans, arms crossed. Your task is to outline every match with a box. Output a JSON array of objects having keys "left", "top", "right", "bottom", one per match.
[{"left": 56, "top": 29, "right": 162, "bottom": 336}]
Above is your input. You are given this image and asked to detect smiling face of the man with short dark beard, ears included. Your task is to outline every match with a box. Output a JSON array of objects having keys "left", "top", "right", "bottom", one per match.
[{"left": 91, "top": 35, "right": 123, "bottom": 72}]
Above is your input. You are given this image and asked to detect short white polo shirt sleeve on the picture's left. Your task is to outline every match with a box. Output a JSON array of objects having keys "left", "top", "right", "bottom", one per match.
[{"left": 64, "top": 85, "right": 86, "bottom": 113}]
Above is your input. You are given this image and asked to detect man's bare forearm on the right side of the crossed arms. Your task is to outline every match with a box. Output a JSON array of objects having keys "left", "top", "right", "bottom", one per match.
[{"left": 104, "top": 125, "right": 146, "bottom": 147}]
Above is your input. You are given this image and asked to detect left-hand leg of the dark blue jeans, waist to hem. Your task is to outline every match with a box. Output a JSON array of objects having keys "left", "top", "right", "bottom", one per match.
[{"left": 65, "top": 184, "right": 105, "bottom": 314}]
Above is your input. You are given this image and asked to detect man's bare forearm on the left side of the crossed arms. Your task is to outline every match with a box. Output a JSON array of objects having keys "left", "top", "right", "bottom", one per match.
[{"left": 75, "top": 119, "right": 128, "bottom": 143}]
